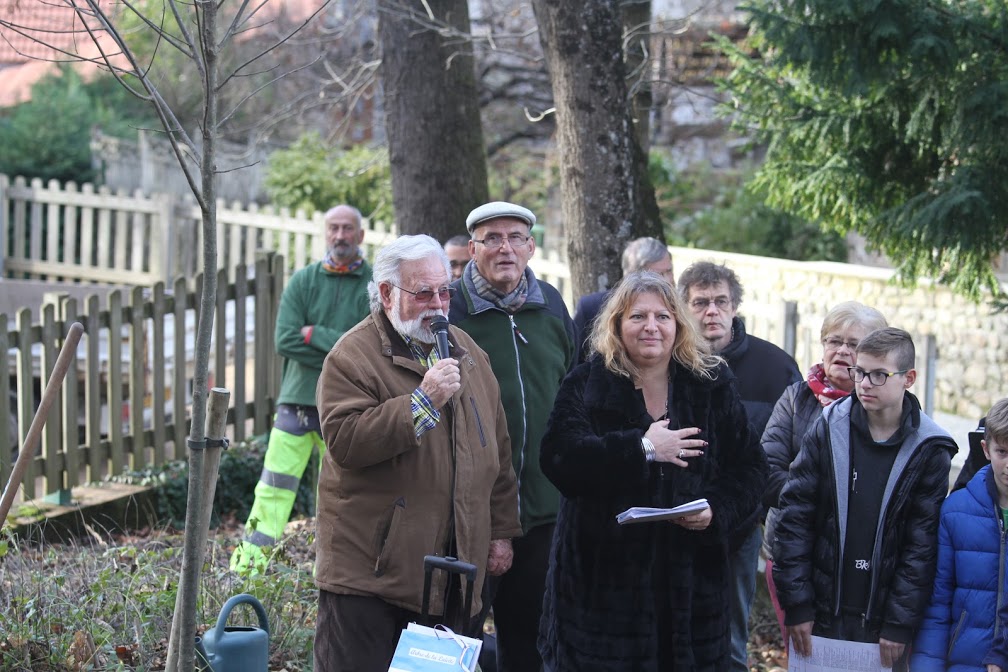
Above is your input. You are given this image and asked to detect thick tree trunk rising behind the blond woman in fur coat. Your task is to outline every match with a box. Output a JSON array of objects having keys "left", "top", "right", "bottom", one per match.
[{"left": 532, "top": 0, "right": 662, "bottom": 296}]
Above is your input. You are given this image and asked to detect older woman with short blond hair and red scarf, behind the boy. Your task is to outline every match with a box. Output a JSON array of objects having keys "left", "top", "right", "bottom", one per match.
[{"left": 762, "top": 301, "right": 888, "bottom": 642}]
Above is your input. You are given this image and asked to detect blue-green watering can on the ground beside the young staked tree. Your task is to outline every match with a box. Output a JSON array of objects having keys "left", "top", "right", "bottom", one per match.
[{"left": 196, "top": 593, "right": 269, "bottom": 672}]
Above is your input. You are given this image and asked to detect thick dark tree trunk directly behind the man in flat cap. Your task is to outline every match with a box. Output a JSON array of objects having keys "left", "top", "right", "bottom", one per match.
[{"left": 379, "top": 0, "right": 488, "bottom": 241}]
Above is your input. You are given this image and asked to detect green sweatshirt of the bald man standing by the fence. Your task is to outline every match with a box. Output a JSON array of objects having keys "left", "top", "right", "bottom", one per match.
[{"left": 275, "top": 261, "right": 371, "bottom": 406}]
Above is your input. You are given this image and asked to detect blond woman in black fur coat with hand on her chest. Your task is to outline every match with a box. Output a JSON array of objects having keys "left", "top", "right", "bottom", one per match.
[{"left": 539, "top": 271, "right": 766, "bottom": 672}]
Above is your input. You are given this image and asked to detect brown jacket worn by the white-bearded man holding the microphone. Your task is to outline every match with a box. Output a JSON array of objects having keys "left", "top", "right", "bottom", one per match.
[{"left": 316, "top": 314, "right": 521, "bottom": 615}]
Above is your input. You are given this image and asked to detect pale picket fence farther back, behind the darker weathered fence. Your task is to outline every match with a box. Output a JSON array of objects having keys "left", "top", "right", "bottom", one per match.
[{"left": 0, "top": 174, "right": 397, "bottom": 286}]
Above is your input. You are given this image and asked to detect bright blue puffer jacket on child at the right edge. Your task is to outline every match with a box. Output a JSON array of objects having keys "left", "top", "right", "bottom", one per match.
[{"left": 910, "top": 465, "right": 1005, "bottom": 672}]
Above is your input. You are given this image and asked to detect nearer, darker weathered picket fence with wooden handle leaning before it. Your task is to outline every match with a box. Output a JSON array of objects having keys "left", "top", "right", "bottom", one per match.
[{"left": 0, "top": 254, "right": 284, "bottom": 499}]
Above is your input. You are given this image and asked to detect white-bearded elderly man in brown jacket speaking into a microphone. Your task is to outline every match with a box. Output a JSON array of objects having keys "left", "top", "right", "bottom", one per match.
[{"left": 314, "top": 236, "right": 521, "bottom": 672}]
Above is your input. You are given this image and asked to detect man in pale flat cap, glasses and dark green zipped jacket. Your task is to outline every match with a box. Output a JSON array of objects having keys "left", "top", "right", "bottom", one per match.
[{"left": 449, "top": 201, "right": 576, "bottom": 672}]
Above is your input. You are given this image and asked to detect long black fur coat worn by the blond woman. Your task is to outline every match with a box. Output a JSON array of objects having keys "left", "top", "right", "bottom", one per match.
[{"left": 539, "top": 358, "right": 767, "bottom": 672}]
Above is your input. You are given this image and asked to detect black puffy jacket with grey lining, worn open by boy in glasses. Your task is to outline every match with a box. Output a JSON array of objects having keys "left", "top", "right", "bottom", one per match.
[{"left": 773, "top": 393, "right": 958, "bottom": 644}]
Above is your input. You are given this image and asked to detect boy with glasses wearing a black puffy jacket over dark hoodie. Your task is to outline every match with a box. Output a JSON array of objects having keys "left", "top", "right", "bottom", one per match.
[{"left": 773, "top": 327, "right": 958, "bottom": 671}]
